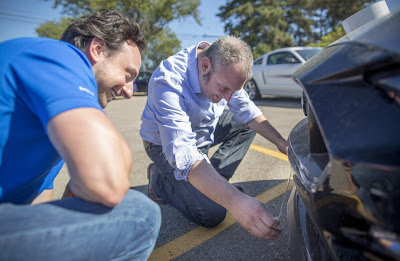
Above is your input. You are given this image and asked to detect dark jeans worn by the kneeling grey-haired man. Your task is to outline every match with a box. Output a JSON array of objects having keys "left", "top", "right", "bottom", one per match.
[{"left": 146, "top": 110, "right": 256, "bottom": 227}]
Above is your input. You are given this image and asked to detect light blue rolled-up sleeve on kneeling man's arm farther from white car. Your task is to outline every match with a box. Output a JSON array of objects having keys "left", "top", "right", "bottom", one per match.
[{"left": 148, "top": 81, "right": 208, "bottom": 181}]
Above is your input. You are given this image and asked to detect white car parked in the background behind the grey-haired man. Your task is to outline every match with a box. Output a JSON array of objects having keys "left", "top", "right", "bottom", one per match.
[{"left": 244, "top": 47, "right": 322, "bottom": 100}]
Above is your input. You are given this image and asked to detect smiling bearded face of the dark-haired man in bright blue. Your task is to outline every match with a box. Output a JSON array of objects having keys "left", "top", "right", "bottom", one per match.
[{"left": 89, "top": 38, "right": 142, "bottom": 108}]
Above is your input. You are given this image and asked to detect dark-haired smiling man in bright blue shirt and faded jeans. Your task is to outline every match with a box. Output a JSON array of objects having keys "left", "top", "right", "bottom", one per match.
[{"left": 0, "top": 10, "right": 161, "bottom": 260}]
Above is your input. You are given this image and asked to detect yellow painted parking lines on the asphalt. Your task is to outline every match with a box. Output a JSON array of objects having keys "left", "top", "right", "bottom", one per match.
[{"left": 148, "top": 145, "right": 293, "bottom": 261}]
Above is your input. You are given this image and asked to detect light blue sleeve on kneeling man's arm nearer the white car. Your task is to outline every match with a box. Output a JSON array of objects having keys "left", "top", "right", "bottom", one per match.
[{"left": 228, "top": 89, "right": 262, "bottom": 124}]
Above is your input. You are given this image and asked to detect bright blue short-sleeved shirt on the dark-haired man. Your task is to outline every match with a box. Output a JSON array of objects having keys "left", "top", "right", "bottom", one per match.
[{"left": 0, "top": 38, "right": 102, "bottom": 204}]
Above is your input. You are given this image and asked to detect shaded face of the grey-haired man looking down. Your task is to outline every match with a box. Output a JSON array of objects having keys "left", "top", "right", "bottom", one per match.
[{"left": 198, "top": 57, "right": 246, "bottom": 103}]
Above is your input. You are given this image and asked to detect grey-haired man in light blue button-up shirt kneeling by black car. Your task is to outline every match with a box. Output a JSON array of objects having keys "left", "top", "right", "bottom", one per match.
[{"left": 140, "top": 36, "right": 287, "bottom": 239}]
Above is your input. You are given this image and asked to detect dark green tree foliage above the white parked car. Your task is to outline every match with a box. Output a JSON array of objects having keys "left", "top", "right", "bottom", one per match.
[{"left": 217, "top": 0, "right": 376, "bottom": 58}]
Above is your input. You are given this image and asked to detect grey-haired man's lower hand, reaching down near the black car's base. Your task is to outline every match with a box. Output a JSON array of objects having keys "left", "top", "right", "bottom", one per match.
[{"left": 229, "top": 193, "right": 281, "bottom": 240}]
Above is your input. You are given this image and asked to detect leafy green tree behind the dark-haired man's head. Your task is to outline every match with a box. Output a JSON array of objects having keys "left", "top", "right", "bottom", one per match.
[{"left": 37, "top": 0, "right": 201, "bottom": 69}]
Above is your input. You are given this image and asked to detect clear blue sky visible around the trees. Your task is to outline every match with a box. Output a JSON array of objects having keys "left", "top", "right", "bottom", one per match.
[{"left": 0, "top": 0, "right": 226, "bottom": 48}]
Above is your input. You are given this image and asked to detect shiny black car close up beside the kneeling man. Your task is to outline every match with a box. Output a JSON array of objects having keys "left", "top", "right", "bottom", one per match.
[{"left": 287, "top": 7, "right": 400, "bottom": 261}]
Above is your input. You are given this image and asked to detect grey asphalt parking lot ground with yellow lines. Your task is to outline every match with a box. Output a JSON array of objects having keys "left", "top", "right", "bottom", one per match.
[{"left": 53, "top": 94, "right": 304, "bottom": 261}]
